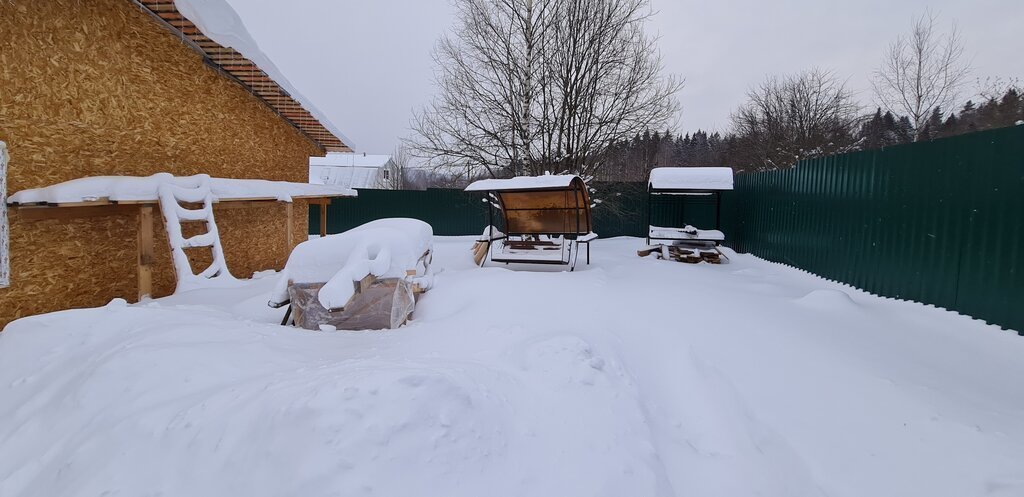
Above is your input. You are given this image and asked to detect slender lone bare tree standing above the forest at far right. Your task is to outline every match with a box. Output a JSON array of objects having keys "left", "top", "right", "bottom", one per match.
[{"left": 872, "top": 11, "right": 970, "bottom": 140}]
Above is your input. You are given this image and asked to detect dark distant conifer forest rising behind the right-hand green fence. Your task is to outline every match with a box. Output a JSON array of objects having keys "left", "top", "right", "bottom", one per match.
[{"left": 596, "top": 86, "right": 1024, "bottom": 181}]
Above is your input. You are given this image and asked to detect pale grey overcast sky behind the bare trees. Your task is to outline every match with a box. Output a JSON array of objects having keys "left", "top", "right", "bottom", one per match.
[{"left": 230, "top": 0, "right": 1024, "bottom": 154}]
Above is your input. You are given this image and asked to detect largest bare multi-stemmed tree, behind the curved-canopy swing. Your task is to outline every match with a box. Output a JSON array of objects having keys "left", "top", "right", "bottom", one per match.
[{"left": 409, "top": 0, "right": 681, "bottom": 177}]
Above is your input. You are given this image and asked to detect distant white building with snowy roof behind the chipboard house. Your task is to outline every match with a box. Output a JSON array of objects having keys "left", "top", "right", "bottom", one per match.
[{"left": 309, "top": 152, "right": 401, "bottom": 190}]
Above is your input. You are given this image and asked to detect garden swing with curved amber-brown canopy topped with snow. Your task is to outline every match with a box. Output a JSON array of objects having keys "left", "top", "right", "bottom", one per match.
[{"left": 466, "top": 174, "right": 597, "bottom": 271}]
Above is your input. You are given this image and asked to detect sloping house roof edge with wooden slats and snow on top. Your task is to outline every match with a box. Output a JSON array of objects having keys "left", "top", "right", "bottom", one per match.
[{"left": 132, "top": 0, "right": 351, "bottom": 152}]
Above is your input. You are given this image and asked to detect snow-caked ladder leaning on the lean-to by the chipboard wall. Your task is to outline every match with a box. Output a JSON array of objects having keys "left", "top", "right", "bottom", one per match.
[{"left": 157, "top": 174, "right": 237, "bottom": 292}]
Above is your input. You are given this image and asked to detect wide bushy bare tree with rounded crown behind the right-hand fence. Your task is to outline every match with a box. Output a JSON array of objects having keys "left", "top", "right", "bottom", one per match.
[{"left": 732, "top": 69, "right": 861, "bottom": 169}]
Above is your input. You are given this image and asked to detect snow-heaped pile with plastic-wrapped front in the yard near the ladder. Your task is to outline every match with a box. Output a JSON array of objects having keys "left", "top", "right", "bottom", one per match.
[{"left": 268, "top": 218, "right": 433, "bottom": 330}]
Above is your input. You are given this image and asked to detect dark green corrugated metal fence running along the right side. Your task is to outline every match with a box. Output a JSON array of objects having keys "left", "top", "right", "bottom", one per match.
[{"left": 724, "top": 126, "right": 1024, "bottom": 332}]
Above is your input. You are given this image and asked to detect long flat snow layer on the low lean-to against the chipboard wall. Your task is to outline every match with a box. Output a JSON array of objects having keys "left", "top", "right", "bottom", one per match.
[{"left": 7, "top": 172, "right": 356, "bottom": 204}]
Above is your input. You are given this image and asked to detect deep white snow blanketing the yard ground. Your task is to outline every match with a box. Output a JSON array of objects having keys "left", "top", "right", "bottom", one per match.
[{"left": 0, "top": 238, "right": 1024, "bottom": 497}]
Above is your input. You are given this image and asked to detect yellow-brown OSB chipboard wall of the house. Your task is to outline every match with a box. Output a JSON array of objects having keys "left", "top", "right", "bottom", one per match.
[{"left": 0, "top": 0, "right": 323, "bottom": 326}]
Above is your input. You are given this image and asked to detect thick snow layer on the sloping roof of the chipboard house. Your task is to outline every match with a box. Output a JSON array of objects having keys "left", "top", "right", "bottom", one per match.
[{"left": 174, "top": 0, "right": 354, "bottom": 149}]
